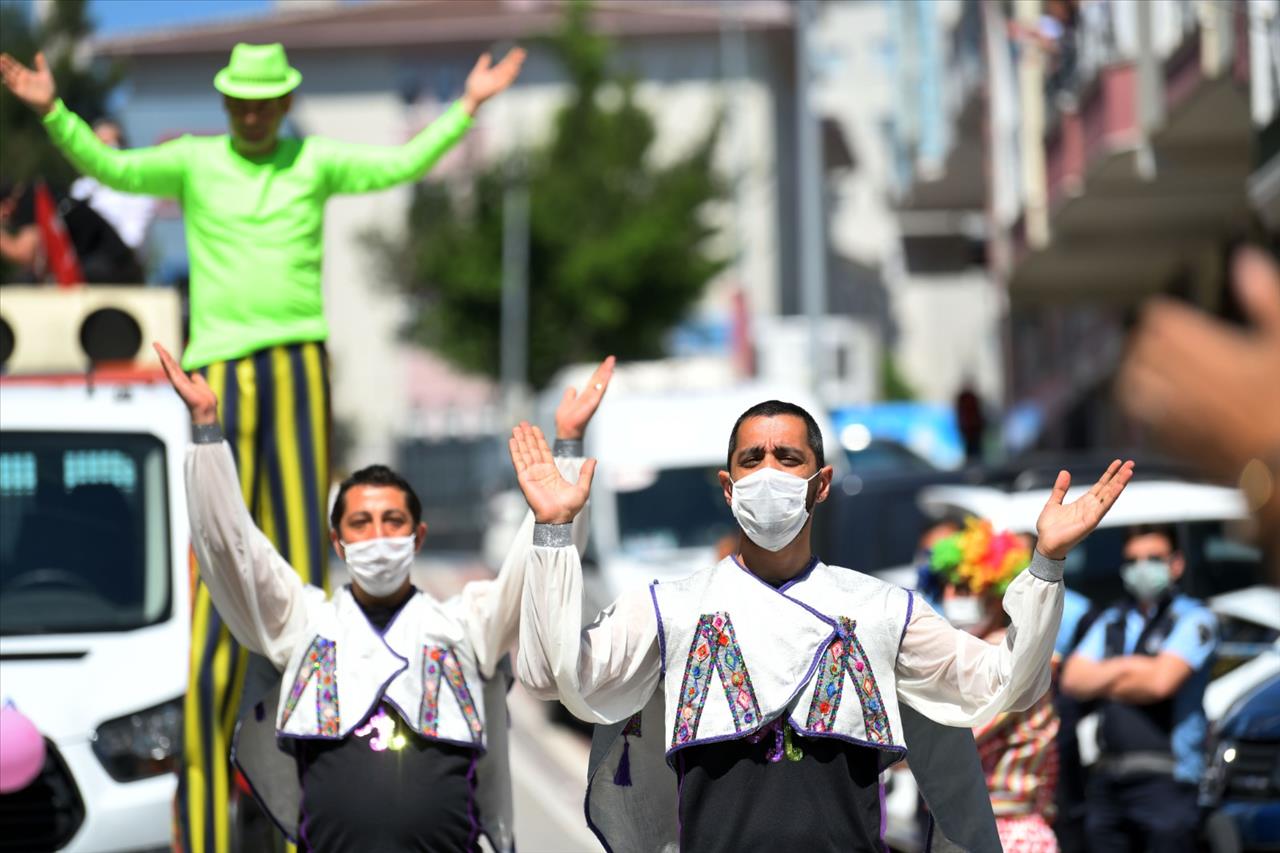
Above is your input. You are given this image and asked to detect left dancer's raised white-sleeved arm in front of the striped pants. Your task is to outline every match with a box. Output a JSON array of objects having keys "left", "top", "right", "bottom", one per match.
[{"left": 156, "top": 345, "right": 306, "bottom": 670}]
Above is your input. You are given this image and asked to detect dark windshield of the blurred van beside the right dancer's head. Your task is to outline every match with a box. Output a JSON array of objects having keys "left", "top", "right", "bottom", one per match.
[{"left": 617, "top": 466, "right": 737, "bottom": 553}]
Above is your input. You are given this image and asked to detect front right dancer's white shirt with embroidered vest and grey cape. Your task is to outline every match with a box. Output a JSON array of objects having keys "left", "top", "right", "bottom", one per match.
[{"left": 517, "top": 525, "right": 1062, "bottom": 850}]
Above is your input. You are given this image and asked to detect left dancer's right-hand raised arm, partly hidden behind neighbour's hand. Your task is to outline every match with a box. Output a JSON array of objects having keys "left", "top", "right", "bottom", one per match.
[{"left": 461, "top": 356, "right": 614, "bottom": 676}]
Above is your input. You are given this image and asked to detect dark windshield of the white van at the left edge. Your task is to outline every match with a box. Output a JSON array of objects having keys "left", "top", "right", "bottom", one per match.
[{"left": 0, "top": 432, "right": 172, "bottom": 635}]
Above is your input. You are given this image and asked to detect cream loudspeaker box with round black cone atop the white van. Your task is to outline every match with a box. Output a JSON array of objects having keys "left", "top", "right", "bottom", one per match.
[{"left": 0, "top": 284, "right": 182, "bottom": 375}]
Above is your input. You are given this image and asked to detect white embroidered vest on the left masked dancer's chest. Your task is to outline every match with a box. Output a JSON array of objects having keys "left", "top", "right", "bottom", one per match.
[{"left": 275, "top": 587, "right": 486, "bottom": 751}]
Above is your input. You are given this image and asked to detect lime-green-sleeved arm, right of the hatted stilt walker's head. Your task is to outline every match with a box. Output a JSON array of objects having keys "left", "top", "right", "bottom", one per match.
[{"left": 320, "top": 47, "right": 525, "bottom": 195}]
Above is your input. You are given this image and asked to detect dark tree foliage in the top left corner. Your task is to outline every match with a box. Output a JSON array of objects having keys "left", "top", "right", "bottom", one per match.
[{"left": 0, "top": 0, "right": 120, "bottom": 187}]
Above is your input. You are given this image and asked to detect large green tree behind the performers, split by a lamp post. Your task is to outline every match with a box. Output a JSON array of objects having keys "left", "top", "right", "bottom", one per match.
[{"left": 379, "top": 4, "right": 723, "bottom": 387}]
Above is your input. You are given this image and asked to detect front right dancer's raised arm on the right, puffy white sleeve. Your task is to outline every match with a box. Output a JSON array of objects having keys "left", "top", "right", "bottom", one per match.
[{"left": 897, "top": 460, "right": 1133, "bottom": 726}]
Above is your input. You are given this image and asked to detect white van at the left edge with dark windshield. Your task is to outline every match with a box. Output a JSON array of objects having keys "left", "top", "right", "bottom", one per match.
[{"left": 0, "top": 288, "right": 192, "bottom": 853}]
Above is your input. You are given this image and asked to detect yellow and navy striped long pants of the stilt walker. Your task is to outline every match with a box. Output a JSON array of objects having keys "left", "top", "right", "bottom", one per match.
[{"left": 178, "top": 343, "right": 330, "bottom": 853}]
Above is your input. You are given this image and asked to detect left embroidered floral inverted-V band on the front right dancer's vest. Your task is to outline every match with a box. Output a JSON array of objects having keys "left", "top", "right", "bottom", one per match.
[{"left": 671, "top": 612, "right": 760, "bottom": 747}]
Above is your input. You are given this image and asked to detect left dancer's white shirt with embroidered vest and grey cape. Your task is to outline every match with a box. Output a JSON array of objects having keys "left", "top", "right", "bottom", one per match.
[{"left": 186, "top": 442, "right": 586, "bottom": 849}]
